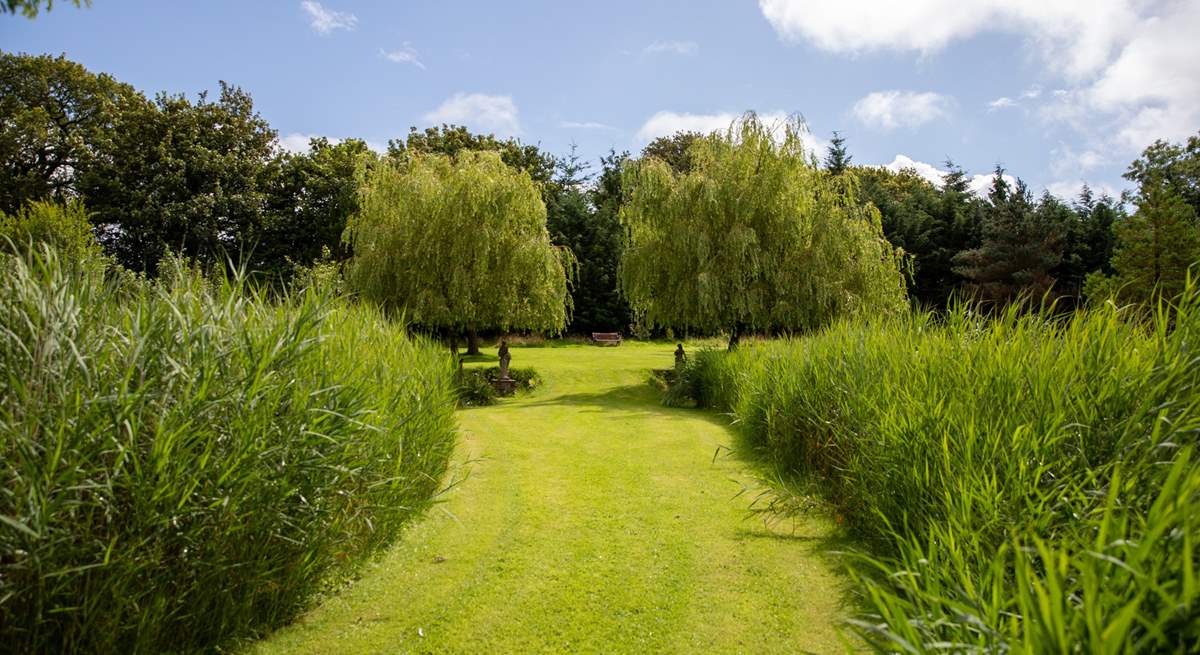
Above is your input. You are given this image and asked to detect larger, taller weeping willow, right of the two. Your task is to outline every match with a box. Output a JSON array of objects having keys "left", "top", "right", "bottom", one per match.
[{"left": 619, "top": 113, "right": 906, "bottom": 348}]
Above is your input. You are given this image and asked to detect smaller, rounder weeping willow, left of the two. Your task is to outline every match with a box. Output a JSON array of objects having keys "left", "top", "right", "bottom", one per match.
[{"left": 344, "top": 151, "right": 574, "bottom": 348}]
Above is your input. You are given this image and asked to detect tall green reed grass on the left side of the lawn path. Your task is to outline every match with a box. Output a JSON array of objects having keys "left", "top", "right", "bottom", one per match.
[{"left": 0, "top": 248, "right": 455, "bottom": 653}]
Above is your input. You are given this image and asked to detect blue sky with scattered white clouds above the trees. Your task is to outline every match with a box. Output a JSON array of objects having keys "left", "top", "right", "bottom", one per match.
[{"left": 0, "top": 0, "right": 1200, "bottom": 197}]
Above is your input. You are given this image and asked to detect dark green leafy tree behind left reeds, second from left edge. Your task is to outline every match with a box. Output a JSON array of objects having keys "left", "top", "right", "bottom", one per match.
[{"left": 78, "top": 83, "right": 275, "bottom": 274}]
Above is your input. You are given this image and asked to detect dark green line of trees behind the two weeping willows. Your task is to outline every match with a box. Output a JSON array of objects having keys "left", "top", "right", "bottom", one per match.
[{"left": 7, "top": 53, "right": 1200, "bottom": 332}]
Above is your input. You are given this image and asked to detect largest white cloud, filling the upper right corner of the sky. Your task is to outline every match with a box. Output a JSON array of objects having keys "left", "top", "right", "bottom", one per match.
[{"left": 758, "top": 0, "right": 1200, "bottom": 154}]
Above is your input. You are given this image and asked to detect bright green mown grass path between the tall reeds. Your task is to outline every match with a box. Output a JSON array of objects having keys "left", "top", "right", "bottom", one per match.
[{"left": 251, "top": 343, "right": 846, "bottom": 654}]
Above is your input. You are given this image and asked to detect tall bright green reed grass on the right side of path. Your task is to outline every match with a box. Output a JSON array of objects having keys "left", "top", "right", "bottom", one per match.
[{"left": 689, "top": 292, "right": 1200, "bottom": 653}]
